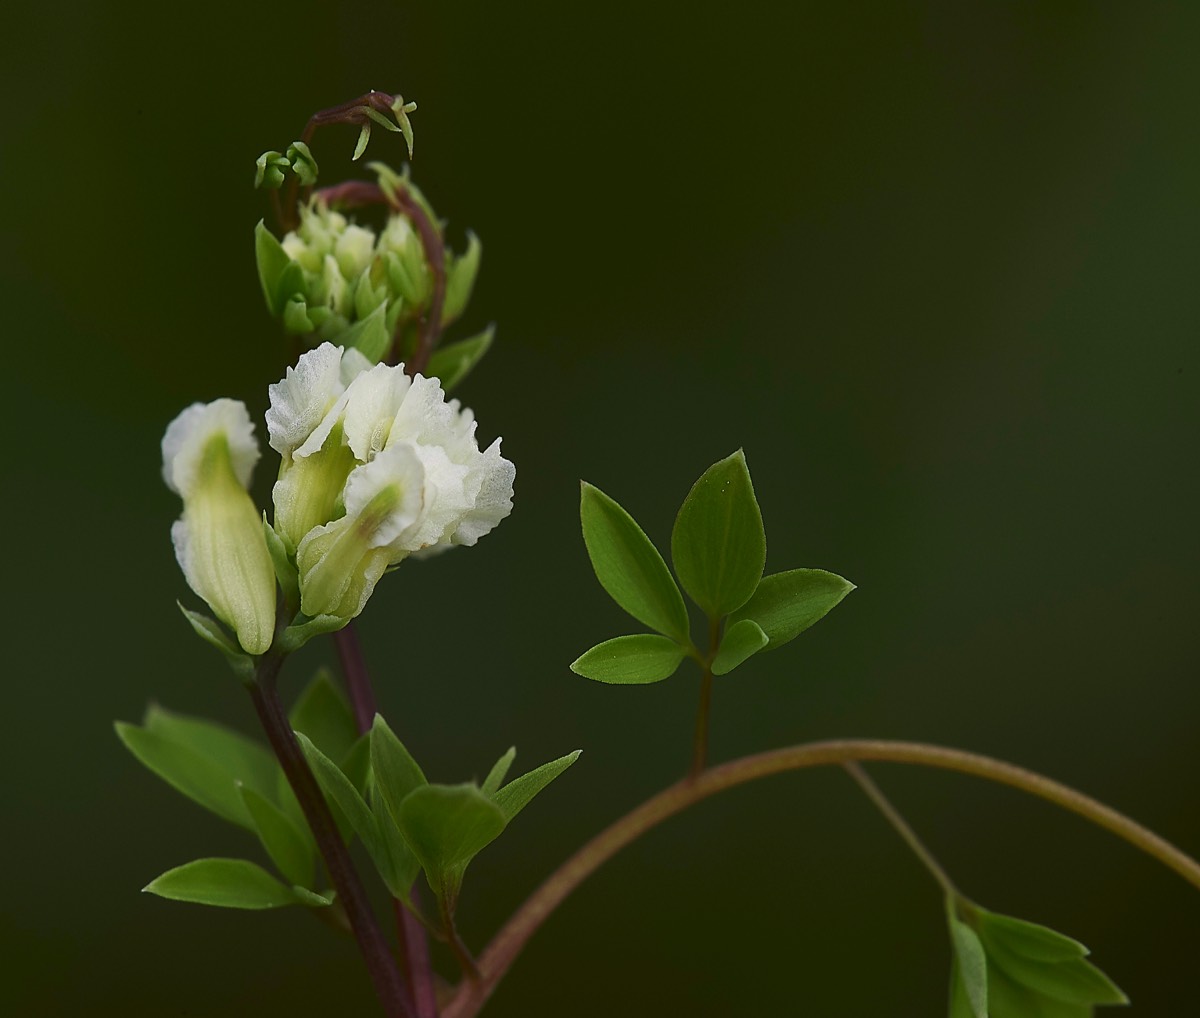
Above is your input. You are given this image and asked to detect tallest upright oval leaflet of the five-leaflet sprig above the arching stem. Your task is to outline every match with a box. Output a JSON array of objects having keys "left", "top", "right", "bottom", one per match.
[{"left": 671, "top": 449, "right": 767, "bottom": 618}]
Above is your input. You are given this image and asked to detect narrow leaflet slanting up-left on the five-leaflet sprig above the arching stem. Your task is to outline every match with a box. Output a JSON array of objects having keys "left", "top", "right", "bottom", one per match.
[{"left": 580, "top": 481, "right": 689, "bottom": 638}]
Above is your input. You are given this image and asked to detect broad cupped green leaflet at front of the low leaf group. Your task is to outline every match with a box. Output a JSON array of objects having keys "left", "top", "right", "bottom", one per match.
[{"left": 396, "top": 784, "right": 505, "bottom": 911}]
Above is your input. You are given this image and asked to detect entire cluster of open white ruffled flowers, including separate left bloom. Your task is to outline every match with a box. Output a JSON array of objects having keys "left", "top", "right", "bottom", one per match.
[{"left": 162, "top": 343, "right": 516, "bottom": 654}]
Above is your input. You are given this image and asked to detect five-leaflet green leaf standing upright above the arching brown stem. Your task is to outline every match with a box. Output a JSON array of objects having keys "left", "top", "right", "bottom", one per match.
[{"left": 571, "top": 449, "right": 854, "bottom": 683}]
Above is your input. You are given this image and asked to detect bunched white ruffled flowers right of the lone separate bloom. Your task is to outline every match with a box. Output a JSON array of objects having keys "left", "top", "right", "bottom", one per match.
[{"left": 266, "top": 343, "right": 516, "bottom": 618}]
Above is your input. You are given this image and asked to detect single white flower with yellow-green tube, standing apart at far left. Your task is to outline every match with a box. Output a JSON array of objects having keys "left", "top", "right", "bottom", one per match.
[{"left": 162, "top": 400, "right": 275, "bottom": 654}]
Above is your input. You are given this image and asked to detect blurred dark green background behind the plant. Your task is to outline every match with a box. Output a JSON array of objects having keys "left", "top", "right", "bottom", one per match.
[{"left": 0, "top": 0, "right": 1200, "bottom": 1018}]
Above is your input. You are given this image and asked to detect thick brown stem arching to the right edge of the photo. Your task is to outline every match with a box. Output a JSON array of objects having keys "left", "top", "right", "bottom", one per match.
[{"left": 443, "top": 739, "right": 1200, "bottom": 1018}]
